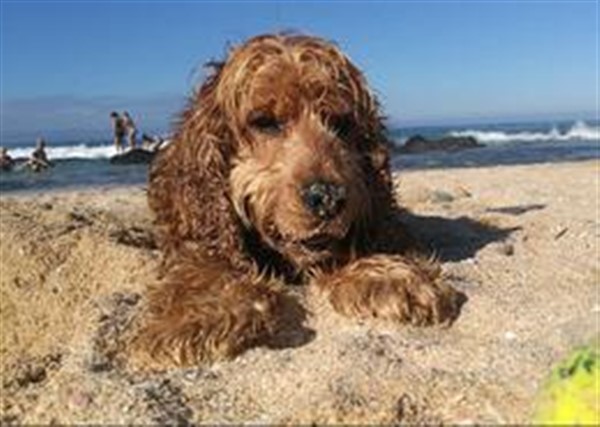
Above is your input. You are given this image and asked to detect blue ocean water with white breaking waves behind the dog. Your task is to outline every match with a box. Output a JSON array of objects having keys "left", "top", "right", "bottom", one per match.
[{"left": 0, "top": 120, "right": 600, "bottom": 194}]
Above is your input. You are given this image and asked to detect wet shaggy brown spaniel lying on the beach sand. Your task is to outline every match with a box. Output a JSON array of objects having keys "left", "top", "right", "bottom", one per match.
[{"left": 139, "top": 35, "right": 457, "bottom": 365}]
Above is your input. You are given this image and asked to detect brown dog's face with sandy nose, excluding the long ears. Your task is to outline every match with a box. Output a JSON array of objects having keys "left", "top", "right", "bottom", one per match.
[{"left": 217, "top": 36, "right": 380, "bottom": 268}]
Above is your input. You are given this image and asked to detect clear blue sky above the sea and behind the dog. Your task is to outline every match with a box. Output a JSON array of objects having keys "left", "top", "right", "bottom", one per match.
[{"left": 0, "top": 0, "right": 599, "bottom": 139}]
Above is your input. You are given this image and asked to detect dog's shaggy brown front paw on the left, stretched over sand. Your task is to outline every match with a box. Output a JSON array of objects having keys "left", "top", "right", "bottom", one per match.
[{"left": 131, "top": 286, "right": 281, "bottom": 370}]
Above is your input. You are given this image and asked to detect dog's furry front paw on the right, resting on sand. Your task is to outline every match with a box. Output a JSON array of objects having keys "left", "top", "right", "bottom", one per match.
[{"left": 321, "top": 255, "right": 463, "bottom": 325}]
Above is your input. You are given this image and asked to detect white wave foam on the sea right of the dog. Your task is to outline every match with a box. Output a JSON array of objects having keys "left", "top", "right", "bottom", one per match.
[{"left": 449, "top": 121, "right": 600, "bottom": 143}]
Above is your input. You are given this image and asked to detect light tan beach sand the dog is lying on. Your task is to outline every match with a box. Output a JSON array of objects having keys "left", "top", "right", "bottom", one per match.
[{"left": 0, "top": 161, "right": 600, "bottom": 424}]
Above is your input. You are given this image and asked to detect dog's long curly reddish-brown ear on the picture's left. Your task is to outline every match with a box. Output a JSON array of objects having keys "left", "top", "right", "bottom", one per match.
[{"left": 148, "top": 63, "right": 239, "bottom": 259}]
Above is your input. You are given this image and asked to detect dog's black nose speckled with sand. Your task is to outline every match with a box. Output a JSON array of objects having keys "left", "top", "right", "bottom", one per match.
[{"left": 302, "top": 181, "right": 346, "bottom": 220}]
